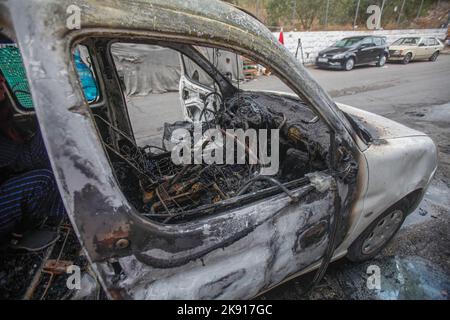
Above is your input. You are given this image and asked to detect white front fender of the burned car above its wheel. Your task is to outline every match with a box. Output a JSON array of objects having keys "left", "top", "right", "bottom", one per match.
[{"left": 356, "top": 135, "right": 437, "bottom": 236}]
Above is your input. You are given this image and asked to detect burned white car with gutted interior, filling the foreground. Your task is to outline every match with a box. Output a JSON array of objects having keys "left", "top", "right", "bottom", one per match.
[{"left": 0, "top": 0, "right": 437, "bottom": 299}]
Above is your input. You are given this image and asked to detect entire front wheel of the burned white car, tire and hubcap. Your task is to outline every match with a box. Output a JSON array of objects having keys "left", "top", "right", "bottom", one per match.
[{"left": 347, "top": 205, "right": 406, "bottom": 262}]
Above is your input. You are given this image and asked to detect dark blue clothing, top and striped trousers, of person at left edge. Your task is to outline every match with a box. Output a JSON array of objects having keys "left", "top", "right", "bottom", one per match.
[{"left": 0, "top": 132, "right": 65, "bottom": 239}]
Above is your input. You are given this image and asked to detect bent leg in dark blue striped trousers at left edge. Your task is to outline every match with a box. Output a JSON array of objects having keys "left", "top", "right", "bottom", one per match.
[{"left": 0, "top": 169, "right": 65, "bottom": 239}]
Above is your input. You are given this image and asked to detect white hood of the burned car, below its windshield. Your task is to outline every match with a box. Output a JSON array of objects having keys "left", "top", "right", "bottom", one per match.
[{"left": 336, "top": 103, "right": 426, "bottom": 141}]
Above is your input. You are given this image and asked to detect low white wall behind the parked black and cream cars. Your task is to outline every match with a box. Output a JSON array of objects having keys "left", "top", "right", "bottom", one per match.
[{"left": 273, "top": 29, "right": 447, "bottom": 64}]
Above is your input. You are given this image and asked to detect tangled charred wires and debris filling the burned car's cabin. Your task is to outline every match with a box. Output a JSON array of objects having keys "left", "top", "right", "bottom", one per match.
[{"left": 101, "top": 92, "right": 330, "bottom": 223}]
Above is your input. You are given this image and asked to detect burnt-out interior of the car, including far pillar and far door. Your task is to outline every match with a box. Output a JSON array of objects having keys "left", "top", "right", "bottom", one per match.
[{"left": 84, "top": 39, "right": 330, "bottom": 224}]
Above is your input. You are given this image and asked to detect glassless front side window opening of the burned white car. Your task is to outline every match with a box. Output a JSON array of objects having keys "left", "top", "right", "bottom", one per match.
[{"left": 97, "top": 42, "right": 330, "bottom": 223}]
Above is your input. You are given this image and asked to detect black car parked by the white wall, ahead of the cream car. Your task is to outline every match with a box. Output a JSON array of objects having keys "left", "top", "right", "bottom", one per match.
[{"left": 316, "top": 36, "right": 389, "bottom": 71}]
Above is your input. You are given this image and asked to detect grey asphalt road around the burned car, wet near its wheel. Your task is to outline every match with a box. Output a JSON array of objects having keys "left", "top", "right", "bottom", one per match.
[{"left": 130, "top": 55, "right": 450, "bottom": 299}]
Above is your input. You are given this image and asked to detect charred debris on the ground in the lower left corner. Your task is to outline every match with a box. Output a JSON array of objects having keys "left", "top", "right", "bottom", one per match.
[{"left": 0, "top": 221, "right": 101, "bottom": 300}]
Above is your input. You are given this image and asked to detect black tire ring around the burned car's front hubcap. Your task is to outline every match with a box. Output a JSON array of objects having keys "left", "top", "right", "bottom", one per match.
[{"left": 347, "top": 201, "right": 407, "bottom": 262}]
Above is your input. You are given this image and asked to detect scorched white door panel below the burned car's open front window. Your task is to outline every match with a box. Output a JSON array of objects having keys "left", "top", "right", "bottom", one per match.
[{"left": 82, "top": 39, "right": 350, "bottom": 299}]
